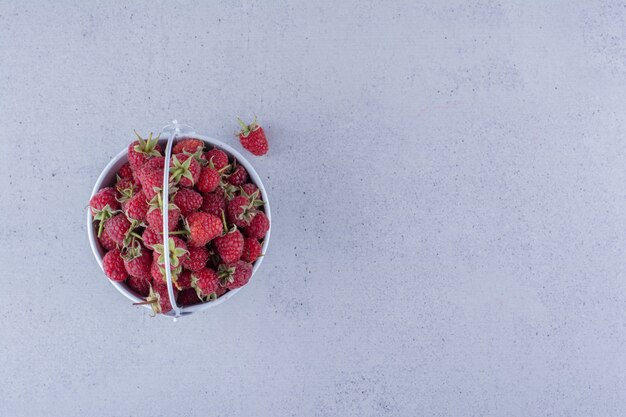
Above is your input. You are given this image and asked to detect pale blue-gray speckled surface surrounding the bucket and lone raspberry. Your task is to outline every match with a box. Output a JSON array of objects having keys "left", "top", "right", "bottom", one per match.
[{"left": 0, "top": 0, "right": 626, "bottom": 417}]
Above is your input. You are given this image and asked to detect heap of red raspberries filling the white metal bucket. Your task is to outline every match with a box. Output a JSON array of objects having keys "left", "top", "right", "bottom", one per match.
[{"left": 89, "top": 134, "right": 270, "bottom": 314}]
